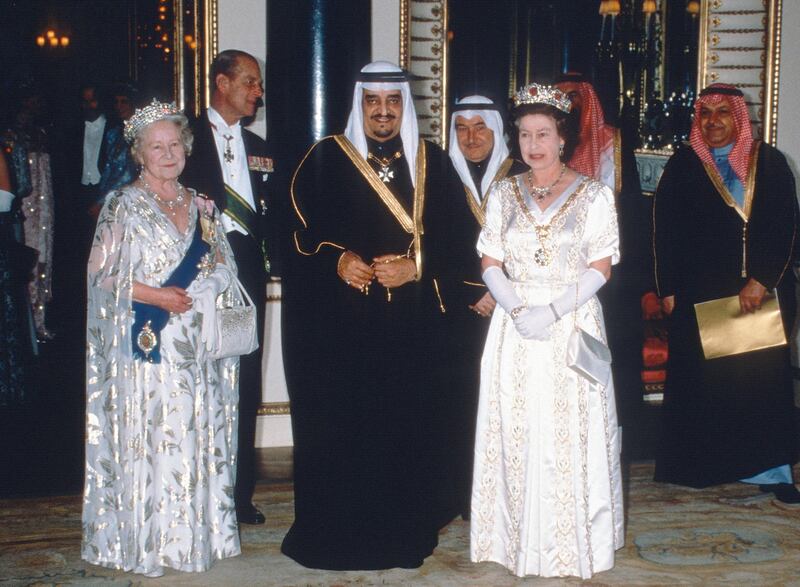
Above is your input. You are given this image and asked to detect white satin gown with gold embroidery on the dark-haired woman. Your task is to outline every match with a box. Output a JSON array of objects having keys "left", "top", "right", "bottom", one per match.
[{"left": 470, "top": 175, "right": 624, "bottom": 578}]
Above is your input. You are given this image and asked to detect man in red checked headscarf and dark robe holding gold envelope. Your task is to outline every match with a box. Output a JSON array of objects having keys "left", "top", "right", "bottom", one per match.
[{"left": 653, "top": 84, "right": 800, "bottom": 503}]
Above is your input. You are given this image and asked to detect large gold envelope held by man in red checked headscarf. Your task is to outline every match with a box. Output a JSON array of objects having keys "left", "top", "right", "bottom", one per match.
[{"left": 694, "top": 295, "right": 786, "bottom": 359}]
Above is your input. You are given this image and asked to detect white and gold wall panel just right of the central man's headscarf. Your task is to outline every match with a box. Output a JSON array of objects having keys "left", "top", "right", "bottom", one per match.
[{"left": 400, "top": 0, "right": 447, "bottom": 147}]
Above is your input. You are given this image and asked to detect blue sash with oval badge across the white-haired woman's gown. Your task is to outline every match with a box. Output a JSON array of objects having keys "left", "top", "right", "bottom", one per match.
[{"left": 131, "top": 213, "right": 211, "bottom": 363}]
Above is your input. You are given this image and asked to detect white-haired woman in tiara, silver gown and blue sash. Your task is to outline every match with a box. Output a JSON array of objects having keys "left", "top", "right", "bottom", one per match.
[{"left": 82, "top": 100, "right": 240, "bottom": 576}]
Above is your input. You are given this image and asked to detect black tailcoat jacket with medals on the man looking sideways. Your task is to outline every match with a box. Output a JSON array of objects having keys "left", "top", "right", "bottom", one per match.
[{"left": 181, "top": 112, "right": 278, "bottom": 274}]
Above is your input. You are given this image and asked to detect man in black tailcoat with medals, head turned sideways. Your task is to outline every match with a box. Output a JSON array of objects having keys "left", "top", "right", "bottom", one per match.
[{"left": 181, "top": 50, "right": 273, "bottom": 524}]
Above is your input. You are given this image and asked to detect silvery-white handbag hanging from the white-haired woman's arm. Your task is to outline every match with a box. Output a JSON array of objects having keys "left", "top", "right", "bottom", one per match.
[{"left": 209, "top": 277, "right": 258, "bottom": 359}]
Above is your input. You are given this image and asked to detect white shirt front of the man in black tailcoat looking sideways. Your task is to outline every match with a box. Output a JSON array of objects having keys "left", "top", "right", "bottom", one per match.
[{"left": 208, "top": 108, "right": 256, "bottom": 234}]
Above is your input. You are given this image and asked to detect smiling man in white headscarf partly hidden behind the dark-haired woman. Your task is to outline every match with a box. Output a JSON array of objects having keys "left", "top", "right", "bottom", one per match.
[{"left": 448, "top": 95, "right": 527, "bottom": 514}]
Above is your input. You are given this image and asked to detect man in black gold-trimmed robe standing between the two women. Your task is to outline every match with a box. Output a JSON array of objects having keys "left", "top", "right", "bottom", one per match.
[{"left": 282, "top": 62, "right": 474, "bottom": 570}]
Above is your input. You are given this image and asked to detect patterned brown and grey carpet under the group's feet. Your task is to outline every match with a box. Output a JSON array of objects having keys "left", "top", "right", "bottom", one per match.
[{"left": 0, "top": 463, "right": 800, "bottom": 587}]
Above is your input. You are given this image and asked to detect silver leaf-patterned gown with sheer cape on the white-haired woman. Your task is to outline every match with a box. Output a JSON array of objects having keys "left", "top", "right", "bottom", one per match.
[{"left": 82, "top": 186, "right": 240, "bottom": 576}]
